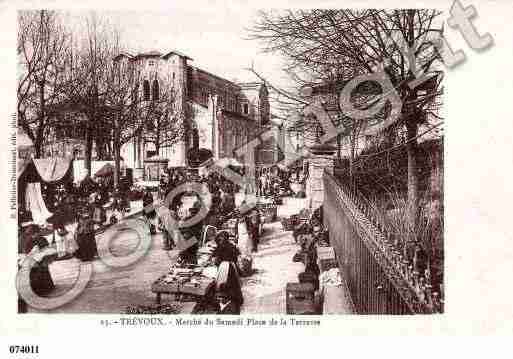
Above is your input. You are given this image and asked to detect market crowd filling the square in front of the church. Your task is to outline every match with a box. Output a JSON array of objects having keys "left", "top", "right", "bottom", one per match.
[{"left": 19, "top": 162, "right": 312, "bottom": 314}]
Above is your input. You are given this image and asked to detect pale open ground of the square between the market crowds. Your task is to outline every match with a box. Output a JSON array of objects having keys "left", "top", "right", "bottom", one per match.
[{"left": 30, "top": 199, "right": 316, "bottom": 314}]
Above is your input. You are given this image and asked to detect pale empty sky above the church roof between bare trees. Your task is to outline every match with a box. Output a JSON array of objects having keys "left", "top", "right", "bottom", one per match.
[{"left": 63, "top": 6, "right": 291, "bottom": 91}]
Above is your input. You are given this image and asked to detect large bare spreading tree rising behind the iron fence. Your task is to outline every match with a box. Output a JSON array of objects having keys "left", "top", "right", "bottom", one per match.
[{"left": 250, "top": 9, "right": 443, "bottom": 229}]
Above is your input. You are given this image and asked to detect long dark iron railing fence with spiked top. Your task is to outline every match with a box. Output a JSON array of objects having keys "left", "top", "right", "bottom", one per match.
[{"left": 323, "top": 172, "right": 443, "bottom": 314}]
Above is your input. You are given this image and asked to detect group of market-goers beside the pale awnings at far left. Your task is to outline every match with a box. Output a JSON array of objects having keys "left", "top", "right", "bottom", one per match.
[{"left": 18, "top": 170, "right": 134, "bottom": 310}]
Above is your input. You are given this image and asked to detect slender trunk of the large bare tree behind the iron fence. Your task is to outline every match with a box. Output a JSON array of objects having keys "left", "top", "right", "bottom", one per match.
[{"left": 406, "top": 120, "right": 419, "bottom": 233}]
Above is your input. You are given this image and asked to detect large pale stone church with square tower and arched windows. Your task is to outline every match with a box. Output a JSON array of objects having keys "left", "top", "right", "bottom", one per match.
[{"left": 114, "top": 51, "right": 280, "bottom": 172}]
